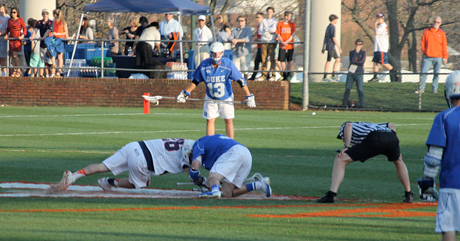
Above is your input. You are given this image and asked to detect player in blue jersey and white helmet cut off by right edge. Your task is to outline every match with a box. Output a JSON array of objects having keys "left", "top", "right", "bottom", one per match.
[{"left": 417, "top": 71, "right": 460, "bottom": 241}]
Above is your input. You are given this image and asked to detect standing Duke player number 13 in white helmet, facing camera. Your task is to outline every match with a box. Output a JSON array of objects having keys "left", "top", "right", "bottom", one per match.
[{"left": 177, "top": 42, "right": 256, "bottom": 139}]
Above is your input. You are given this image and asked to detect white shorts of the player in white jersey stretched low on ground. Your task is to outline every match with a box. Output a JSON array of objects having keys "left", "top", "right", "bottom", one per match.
[{"left": 102, "top": 142, "right": 153, "bottom": 188}]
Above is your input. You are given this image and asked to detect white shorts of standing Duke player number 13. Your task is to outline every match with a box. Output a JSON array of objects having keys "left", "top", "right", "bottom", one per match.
[{"left": 203, "top": 95, "right": 235, "bottom": 120}]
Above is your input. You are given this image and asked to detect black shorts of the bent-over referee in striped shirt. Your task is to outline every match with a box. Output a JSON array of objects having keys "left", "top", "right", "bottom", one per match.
[{"left": 345, "top": 131, "right": 401, "bottom": 162}]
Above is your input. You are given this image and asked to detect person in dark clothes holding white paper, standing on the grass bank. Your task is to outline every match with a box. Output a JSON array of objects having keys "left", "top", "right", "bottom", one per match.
[{"left": 342, "top": 39, "right": 366, "bottom": 108}]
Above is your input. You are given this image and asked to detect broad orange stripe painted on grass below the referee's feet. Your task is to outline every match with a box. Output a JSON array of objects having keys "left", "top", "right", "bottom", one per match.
[{"left": 247, "top": 203, "right": 437, "bottom": 218}]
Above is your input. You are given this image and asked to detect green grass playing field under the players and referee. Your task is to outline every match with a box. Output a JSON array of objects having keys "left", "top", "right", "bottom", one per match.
[{"left": 0, "top": 106, "right": 440, "bottom": 240}]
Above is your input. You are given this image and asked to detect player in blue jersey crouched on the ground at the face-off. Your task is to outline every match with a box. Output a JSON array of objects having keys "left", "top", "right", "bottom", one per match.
[{"left": 182, "top": 134, "right": 272, "bottom": 198}]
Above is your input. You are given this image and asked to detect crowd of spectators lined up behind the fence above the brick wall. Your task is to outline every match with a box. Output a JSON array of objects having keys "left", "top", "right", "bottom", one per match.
[{"left": 0, "top": 4, "right": 296, "bottom": 81}]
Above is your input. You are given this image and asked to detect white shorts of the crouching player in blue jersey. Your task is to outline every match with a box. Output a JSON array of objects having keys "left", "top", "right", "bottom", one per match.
[{"left": 209, "top": 145, "right": 252, "bottom": 188}]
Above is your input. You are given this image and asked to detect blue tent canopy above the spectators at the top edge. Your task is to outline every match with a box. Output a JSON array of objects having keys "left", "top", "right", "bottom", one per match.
[{"left": 83, "top": 0, "right": 211, "bottom": 15}]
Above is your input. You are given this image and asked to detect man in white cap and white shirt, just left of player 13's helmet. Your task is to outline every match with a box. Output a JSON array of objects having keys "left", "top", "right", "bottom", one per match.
[{"left": 193, "top": 15, "right": 212, "bottom": 68}]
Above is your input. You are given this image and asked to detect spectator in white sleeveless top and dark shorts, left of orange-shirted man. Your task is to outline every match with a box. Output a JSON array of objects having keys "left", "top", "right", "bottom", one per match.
[{"left": 369, "top": 13, "right": 400, "bottom": 82}]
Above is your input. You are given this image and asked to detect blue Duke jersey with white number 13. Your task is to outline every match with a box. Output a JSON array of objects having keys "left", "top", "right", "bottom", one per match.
[{"left": 193, "top": 57, "right": 246, "bottom": 100}]
